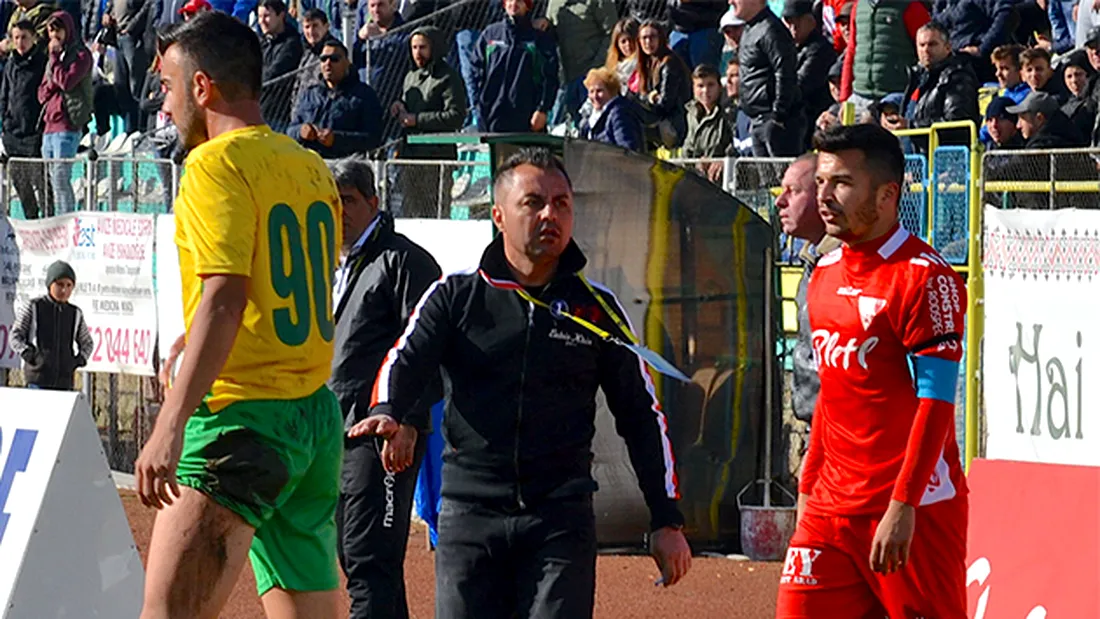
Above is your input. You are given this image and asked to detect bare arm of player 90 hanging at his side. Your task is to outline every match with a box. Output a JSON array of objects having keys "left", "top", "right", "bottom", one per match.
[{"left": 134, "top": 275, "right": 249, "bottom": 509}]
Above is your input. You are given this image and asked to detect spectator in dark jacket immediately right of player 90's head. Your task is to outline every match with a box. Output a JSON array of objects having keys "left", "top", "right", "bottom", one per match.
[{"left": 256, "top": 0, "right": 303, "bottom": 131}]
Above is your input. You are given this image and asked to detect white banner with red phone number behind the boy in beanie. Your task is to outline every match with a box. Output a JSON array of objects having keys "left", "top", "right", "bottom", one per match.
[{"left": 0, "top": 212, "right": 156, "bottom": 376}]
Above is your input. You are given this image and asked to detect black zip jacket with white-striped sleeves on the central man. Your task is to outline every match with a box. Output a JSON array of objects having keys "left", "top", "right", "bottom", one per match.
[{"left": 371, "top": 236, "right": 683, "bottom": 530}]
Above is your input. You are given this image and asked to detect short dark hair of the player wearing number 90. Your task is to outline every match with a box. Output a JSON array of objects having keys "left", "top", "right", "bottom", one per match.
[{"left": 156, "top": 11, "right": 264, "bottom": 100}]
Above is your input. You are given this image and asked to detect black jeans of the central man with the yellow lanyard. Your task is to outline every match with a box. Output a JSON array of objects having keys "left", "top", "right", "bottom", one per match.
[{"left": 436, "top": 495, "right": 596, "bottom": 619}]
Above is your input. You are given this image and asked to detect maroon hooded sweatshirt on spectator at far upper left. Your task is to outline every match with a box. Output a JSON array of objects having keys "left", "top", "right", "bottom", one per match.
[{"left": 39, "top": 11, "right": 91, "bottom": 133}]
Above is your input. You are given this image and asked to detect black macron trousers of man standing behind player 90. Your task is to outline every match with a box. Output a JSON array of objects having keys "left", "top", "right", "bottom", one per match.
[{"left": 337, "top": 436, "right": 428, "bottom": 619}]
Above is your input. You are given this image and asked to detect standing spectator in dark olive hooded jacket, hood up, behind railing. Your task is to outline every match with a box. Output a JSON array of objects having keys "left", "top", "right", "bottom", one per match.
[{"left": 389, "top": 26, "right": 466, "bottom": 218}]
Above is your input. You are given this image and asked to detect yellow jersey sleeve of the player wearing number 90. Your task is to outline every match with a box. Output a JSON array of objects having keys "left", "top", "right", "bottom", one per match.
[{"left": 179, "top": 157, "right": 260, "bottom": 277}]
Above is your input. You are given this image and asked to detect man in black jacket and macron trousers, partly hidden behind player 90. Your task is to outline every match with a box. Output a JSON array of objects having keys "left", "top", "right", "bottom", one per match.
[{"left": 329, "top": 159, "right": 440, "bottom": 619}]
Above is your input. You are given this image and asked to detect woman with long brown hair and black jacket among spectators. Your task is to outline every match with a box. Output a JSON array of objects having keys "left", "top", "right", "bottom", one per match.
[{"left": 628, "top": 21, "right": 691, "bottom": 151}]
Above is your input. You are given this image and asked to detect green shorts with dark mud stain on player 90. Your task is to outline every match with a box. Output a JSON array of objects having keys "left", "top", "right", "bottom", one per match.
[{"left": 176, "top": 387, "right": 343, "bottom": 595}]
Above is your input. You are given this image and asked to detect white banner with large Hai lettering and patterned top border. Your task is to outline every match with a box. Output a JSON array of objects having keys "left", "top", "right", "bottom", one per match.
[{"left": 982, "top": 207, "right": 1100, "bottom": 466}]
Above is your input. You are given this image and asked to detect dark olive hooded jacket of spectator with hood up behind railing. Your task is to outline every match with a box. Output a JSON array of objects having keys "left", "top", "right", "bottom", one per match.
[{"left": 400, "top": 26, "right": 468, "bottom": 159}]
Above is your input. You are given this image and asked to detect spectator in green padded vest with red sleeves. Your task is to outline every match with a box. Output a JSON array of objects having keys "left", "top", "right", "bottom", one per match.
[{"left": 840, "top": 0, "right": 932, "bottom": 118}]
